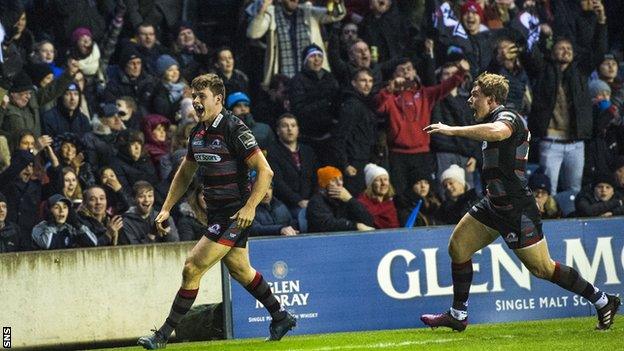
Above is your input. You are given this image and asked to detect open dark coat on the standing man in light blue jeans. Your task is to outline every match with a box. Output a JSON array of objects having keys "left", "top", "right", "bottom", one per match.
[{"left": 524, "top": 25, "right": 607, "bottom": 140}]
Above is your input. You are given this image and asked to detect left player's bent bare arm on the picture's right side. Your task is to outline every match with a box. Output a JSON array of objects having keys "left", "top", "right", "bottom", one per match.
[{"left": 232, "top": 152, "right": 273, "bottom": 229}]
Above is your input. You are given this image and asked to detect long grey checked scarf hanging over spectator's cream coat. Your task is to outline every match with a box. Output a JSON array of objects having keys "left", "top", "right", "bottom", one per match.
[{"left": 275, "top": 6, "right": 310, "bottom": 78}]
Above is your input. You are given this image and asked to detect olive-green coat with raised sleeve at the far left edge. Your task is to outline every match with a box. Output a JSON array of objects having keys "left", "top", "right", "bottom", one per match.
[{"left": 2, "top": 71, "right": 73, "bottom": 137}]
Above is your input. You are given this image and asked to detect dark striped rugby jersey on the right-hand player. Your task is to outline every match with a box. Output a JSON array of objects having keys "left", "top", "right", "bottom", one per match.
[{"left": 482, "top": 106, "right": 533, "bottom": 210}]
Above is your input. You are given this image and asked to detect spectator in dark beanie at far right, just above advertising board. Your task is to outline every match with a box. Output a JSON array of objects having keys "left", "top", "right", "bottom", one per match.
[{"left": 574, "top": 173, "right": 624, "bottom": 217}]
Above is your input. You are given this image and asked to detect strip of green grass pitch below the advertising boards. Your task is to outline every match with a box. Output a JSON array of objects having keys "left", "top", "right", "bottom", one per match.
[{"left": 105, "top": 315, "right": 624, "bottom": 351}]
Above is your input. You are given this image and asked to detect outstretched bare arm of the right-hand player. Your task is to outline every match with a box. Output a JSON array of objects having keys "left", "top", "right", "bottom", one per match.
[{"left": 423, "top": 121, "right": 512, "bottom": 141}]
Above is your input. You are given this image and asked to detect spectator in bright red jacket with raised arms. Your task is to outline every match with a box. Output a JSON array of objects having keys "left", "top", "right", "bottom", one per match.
[{"left": 377, "top": 60, "right": 470, "bottom": 192}]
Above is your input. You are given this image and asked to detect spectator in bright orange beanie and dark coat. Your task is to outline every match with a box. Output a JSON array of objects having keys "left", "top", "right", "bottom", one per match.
[{"left": 306, "top": 166, "right": 375, "bottom": 233}]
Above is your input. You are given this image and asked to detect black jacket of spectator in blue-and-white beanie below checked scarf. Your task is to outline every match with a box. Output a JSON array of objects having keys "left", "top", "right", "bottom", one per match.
[{"left": 289, "top": 69, "right": 340, "bottom": 138}]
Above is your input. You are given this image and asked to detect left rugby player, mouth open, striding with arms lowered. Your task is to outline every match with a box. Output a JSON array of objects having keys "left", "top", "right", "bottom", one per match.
[{"left": 138, "top": 74, "right": 296, "bottom": 350}]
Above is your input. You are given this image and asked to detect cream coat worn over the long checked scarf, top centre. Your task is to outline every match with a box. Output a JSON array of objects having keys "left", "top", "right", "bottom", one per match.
[{"left": 245, "top": 0, "right": 346, "bottom": 89}]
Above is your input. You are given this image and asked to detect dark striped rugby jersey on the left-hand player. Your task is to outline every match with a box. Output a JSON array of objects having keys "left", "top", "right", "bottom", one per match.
[{"left": 186, "top": 109, "right": 260, "bottom": 212}]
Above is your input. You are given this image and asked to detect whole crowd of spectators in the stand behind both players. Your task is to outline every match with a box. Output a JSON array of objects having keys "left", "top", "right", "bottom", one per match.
[{"left": 0, "top": 0, "right": 624, "bottom": 252}]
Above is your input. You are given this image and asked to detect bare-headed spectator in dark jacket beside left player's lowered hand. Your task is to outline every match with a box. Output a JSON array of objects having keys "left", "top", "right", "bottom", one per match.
[{"left": 119, "top": 180, "right": 180, "bottom": 245}]
